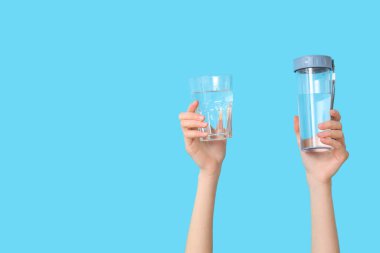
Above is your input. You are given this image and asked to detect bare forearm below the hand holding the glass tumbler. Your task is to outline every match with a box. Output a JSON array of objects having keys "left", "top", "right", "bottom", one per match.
[{"left": 186, "top": 168, "right": 219, "bottom": 253}]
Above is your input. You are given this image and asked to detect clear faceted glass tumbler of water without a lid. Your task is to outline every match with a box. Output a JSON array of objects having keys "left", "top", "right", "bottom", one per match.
[{"left": 190, "top": 75, "right": 233, "bottom": 141}]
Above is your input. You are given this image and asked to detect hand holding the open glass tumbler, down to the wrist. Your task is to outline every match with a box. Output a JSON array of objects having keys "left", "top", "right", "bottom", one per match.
[{"left": 179, "top": 101, "right": 226, "bottom": 175}]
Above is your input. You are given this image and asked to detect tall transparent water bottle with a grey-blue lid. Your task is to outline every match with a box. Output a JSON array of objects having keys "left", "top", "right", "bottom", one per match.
[{"left": 294, "top": 55, "right": 335, "bottom": 151}]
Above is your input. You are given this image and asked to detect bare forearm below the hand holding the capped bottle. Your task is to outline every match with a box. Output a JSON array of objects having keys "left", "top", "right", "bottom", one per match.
[{"left": 309, "top": 182, "right": 339, "bottom": 253}]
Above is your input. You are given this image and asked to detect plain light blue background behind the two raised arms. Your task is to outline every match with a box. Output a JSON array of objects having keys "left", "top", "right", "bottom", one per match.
[{"left": 0, "top": 1, "right": 380, "bottom": 252}]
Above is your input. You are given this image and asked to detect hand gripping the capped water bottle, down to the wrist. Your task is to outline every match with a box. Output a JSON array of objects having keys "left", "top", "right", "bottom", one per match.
[{"left": 294, "top": 110, "right": 349, "bottom": 186}]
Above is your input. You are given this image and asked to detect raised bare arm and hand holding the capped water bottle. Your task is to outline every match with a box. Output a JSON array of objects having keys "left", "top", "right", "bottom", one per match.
[{"left": 294, "top": 110, "right": 348, "bottom": 253}]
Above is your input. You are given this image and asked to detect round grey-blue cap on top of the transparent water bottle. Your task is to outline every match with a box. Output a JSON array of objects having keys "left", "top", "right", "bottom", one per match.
[{"left": 293, "top": 55, "right": 333, "bottom": 71}]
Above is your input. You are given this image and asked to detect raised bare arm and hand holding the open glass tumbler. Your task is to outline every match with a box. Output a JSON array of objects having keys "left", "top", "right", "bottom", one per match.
[{"left": 179, "top": 101, "right": 226, "bottom": 253}]
